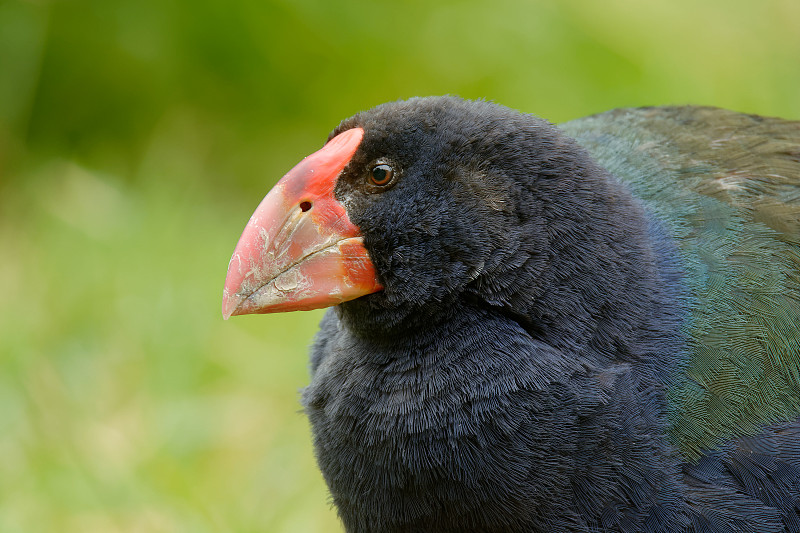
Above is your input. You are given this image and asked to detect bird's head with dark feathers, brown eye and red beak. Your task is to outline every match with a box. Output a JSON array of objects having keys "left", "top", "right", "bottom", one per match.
[{"left": 223, "top": 97, "right": 608, "bottom": 327}]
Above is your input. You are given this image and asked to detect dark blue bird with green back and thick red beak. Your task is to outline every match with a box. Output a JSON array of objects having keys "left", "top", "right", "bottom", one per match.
[{"left": 222, "top": 96, "right": 800, "bottom": 533}]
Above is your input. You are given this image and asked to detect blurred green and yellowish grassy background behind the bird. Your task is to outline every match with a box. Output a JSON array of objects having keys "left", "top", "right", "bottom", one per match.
[{"left": 0, "top": 0, "right": 800, "bottom": 533}]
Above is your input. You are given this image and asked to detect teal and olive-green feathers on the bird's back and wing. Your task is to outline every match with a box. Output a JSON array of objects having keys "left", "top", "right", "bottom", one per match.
[{"left": 562, "top": 107, "right": 800, "bottom": 459}]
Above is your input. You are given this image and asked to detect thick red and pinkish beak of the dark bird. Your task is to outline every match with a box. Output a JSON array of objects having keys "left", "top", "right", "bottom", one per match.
[{"left": 222, "top": 128, "right": 383, "bottom": 319}]
